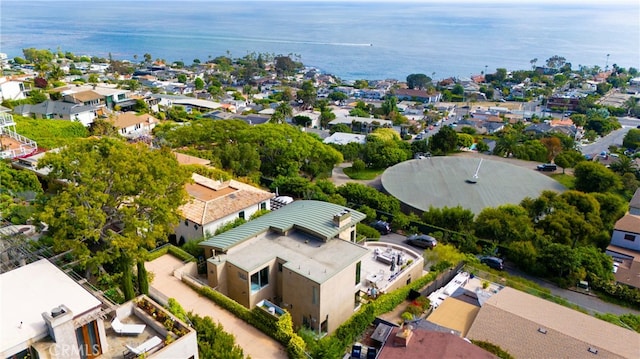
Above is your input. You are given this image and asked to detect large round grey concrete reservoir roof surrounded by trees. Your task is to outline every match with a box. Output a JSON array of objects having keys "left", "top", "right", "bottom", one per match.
[{"left": 381, "top": 156, "right": 566, "bottom": 214}]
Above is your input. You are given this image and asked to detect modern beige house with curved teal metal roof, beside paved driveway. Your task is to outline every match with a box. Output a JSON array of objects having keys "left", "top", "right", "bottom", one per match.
[{"left": 200, "top": 201, "right": 370, "bottom": 334}]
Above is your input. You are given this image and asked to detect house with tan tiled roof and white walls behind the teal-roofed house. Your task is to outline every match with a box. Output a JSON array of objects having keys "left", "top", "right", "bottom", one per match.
[{"left": 175, "top": 173, "right": 275, "bottom": 244}]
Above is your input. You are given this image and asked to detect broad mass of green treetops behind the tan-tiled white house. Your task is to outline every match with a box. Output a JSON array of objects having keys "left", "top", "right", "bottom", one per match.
[{"left": 155, "top": 120, "right": 342, "bottom": 182}]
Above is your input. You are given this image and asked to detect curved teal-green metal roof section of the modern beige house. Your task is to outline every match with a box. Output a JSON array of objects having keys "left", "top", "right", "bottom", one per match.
[{"left": 200, "top": 201, "right": 366, "bottom": 251}]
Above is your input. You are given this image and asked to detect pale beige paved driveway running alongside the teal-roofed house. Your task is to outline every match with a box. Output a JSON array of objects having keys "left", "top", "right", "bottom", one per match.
[{"left": 145, "top": 254, "right": 287, "bottom": 359}]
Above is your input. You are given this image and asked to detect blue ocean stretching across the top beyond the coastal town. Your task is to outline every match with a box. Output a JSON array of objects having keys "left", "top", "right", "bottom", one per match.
[{"left": 0, "top": 0, "right": 640, "bottom": 80}]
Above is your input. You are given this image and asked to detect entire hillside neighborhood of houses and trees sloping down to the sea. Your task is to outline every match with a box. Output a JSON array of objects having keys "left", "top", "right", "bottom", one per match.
[{"left": 0, "top": 49, "right": 640, "bottom": 359}]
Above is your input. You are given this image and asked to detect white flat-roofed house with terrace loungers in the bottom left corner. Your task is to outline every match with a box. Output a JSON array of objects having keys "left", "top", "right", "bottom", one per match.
[{"left": 0, "top": 259, "right": 198, "bottom": 359}]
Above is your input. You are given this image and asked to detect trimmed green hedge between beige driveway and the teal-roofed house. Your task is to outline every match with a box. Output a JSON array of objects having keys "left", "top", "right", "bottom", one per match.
[{"left": 187, "top": 283, "right": 305, "bottom": 359}]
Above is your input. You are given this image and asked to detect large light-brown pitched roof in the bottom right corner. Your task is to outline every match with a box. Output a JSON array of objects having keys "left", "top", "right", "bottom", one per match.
[{"left": 467, "top": 287, "right": 640, "bottom": 358}]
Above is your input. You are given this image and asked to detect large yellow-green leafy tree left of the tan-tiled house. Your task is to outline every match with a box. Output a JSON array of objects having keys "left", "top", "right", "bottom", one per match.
[{"left": 38, "top": 138, "right": 189, "bottom": 299}]
